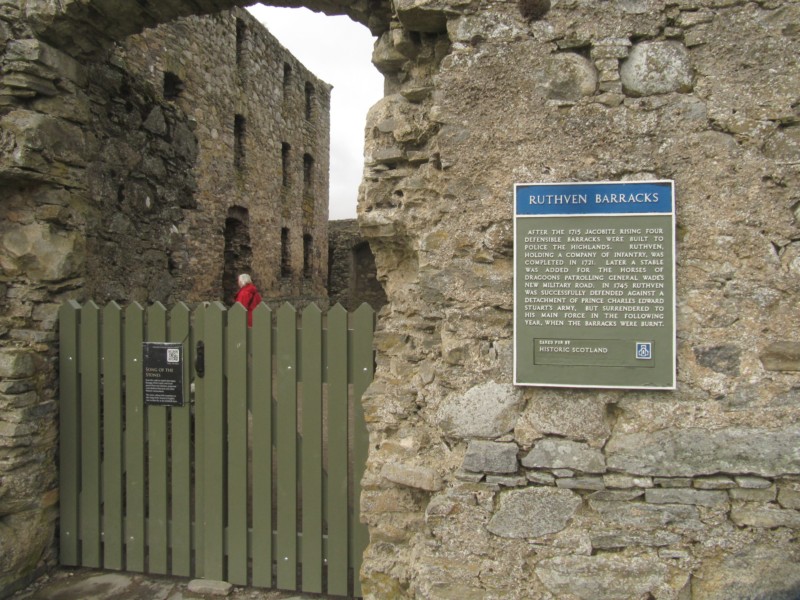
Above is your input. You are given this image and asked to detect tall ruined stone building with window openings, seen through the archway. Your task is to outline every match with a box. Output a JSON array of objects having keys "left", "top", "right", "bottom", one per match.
[{"left": 1, "top": 10, "right": 330, "bottom": 304}]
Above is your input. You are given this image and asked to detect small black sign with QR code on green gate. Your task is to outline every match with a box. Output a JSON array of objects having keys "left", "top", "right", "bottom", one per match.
[{"left": 142, "top": 342, "right": 183, "bottom": 406}]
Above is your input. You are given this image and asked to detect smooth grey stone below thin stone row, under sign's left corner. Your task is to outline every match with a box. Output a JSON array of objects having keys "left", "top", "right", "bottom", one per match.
[{"left": 487, "top": 487, "right": 581, "bottom": 538}]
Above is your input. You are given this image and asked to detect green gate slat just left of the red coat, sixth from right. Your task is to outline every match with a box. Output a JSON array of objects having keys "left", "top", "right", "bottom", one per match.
[{"left": 227, "top": 303, "right": 248, "bottom": 585}]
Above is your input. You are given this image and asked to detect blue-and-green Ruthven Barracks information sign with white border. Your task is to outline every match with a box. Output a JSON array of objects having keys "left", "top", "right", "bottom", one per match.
[{"left": 514, "top": 181, "right": 675, "bottom": 389}]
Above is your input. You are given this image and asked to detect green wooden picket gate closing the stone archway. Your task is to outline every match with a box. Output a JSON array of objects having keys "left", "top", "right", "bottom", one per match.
[{"left": 59, "top": 301, "right": 375, "bottom": 597}]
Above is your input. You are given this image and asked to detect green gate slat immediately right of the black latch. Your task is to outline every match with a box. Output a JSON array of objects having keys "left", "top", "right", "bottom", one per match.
[{"left": 202, "top": 302, "right": 226, "bottom": 580}]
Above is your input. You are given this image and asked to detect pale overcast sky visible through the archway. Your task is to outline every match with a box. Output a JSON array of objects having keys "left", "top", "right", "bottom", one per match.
[{"left": 247, "top": 4, "right": 383, "bottom": 219}]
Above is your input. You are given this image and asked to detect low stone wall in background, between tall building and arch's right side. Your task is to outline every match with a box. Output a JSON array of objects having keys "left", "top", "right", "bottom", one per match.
[{"left": 328, "top": 219, "right": 386, "bottom": 311}]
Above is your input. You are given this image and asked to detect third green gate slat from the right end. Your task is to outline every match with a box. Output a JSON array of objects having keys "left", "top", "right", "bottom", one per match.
[{"left": 301, "top": 304, "right": 323, "bottom": 593}]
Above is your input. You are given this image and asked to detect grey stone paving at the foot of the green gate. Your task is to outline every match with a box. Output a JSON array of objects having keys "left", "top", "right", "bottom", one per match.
[{"left": 9, "top": 569, "right": 331, "bottom": 600}]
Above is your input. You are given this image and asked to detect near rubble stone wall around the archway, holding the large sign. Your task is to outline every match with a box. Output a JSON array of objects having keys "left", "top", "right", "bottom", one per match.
[{"left": 0, "top": 0, "right": 800, "bottom": 600}]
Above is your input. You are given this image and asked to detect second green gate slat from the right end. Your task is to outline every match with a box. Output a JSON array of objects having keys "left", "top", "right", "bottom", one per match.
[{"left": 326, "top": 304, "right": 349, "bottom": 596}]
